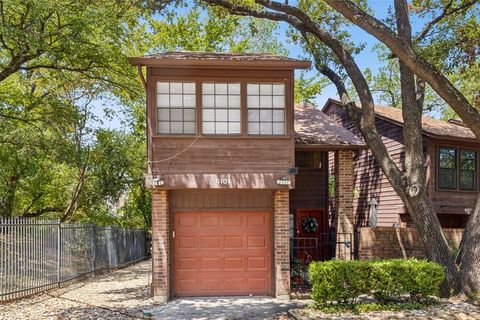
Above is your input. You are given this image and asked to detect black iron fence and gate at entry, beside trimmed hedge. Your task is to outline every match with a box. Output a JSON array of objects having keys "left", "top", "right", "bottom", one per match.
[{"left": 290, "top": 232, "right": 353, "bottom": 291}]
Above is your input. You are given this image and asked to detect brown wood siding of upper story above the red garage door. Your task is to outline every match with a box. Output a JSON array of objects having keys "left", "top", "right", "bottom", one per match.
[{"left": 147, "top": 67, "right": 294, "bottom": 189}]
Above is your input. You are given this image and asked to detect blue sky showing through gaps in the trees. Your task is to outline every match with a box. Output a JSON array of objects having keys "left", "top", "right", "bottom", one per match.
[{"left": 93, "top": 0, "right": 436, "bottom": 129}]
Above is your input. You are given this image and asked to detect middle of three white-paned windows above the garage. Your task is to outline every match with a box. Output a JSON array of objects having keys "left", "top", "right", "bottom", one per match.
[{"left": 202, "top": 82, "right": 241, "bottom": 134}]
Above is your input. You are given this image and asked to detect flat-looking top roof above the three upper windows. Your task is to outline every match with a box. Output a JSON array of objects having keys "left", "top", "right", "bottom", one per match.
[{"left": 129, "top": 51, "right": 310, "bottom": 68}]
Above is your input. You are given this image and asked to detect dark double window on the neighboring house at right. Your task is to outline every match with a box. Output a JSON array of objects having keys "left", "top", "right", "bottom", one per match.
[{"left": 437, "top": 147, "right": 478, "bottom": 191}]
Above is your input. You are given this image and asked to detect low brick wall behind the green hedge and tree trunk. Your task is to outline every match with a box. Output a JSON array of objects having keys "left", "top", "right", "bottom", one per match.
[{"left": 357, "top": 227, "right": 463, "bottom": 260}]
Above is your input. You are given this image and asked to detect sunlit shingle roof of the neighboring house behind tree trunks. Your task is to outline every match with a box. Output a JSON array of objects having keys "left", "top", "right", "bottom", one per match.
[{"left": 322, "top": 99, "right": 476, "bottom": 140}]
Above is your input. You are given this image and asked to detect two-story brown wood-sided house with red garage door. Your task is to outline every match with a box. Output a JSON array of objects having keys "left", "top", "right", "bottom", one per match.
[{"left": 129, "top": 52, "right": 365, "bottom": 302}]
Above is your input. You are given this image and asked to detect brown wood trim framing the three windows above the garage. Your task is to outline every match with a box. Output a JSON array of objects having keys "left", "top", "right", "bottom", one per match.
[{"left": 153, "top": 75, "right": 288, "bottom": 139}]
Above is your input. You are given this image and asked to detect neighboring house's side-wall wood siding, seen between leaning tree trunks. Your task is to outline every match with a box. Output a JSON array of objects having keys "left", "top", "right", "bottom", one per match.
[{"left": 327, "top": 107, "right": 406, "bottom": 227}]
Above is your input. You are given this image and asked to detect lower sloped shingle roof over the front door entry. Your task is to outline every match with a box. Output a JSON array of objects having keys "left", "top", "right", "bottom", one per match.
[{"left": 295, "top": 103, "right": 365, "bottom": 148}]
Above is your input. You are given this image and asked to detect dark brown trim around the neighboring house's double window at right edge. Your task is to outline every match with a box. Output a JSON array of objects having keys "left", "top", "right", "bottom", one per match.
[{"left": 435, "top": 144, "right": 480, "bottom": 193}]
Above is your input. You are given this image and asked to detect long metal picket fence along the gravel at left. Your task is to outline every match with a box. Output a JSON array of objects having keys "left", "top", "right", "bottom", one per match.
[{"left": 0, "top": 218, "right": 148, "bottom": 301}]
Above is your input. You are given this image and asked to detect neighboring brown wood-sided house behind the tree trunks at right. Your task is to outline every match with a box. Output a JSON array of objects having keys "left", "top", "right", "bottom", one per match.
[{"left": 323, "top": 99, "right": 480, "bottom": 228}]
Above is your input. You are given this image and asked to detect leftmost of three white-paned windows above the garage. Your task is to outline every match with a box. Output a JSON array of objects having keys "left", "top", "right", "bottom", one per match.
[{"left": 157, "top": 82, "right": 195, "bottom": 134}]
